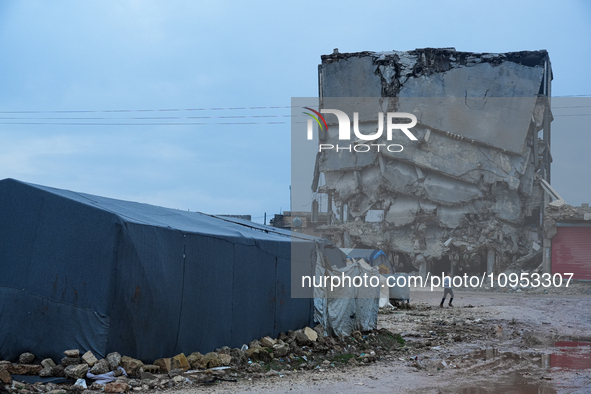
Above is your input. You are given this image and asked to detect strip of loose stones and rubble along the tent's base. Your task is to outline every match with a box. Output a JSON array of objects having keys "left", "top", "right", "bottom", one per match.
[{"left": 0, "top": 325, "right": 404, "bottom": 394}]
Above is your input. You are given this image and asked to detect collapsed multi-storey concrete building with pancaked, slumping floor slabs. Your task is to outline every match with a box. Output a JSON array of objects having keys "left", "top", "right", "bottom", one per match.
[{"left": 311, "top": 48, "right": 552, "bottom": 275}]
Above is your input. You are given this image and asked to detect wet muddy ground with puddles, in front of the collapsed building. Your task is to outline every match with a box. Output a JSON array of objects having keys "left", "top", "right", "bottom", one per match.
[{"left": 172, "top": 284, "right": 591, "bottom": 394}]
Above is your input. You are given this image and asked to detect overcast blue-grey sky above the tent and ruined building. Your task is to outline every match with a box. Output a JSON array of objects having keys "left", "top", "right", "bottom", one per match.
[{"left": 0, "top": 0, "right": 591, "bottom": 222}]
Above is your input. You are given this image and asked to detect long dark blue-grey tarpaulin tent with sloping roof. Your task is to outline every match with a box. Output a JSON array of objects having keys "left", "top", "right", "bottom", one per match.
[{"left": 0, "top": 179, "right": 344, "bottom": 361}]
